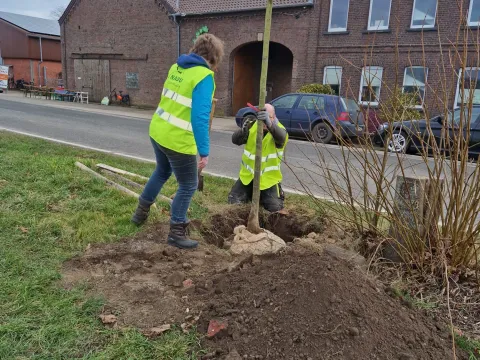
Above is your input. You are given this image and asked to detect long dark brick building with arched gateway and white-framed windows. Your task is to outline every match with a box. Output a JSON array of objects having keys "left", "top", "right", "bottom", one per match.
[{"left": 60, "top": 0, "right": 480, "bottom": 114}]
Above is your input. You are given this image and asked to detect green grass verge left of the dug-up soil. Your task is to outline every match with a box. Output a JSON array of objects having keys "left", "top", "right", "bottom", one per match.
[{"left": 0, "top": 132, "right": 218, "bottom": 360}]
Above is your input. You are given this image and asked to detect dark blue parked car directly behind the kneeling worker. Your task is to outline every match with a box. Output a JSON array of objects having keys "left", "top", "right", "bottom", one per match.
[{"left": 235, "top": 94, "right": 364, "bottom": 144}]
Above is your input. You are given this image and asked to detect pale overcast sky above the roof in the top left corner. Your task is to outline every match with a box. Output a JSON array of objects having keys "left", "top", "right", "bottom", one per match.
[{"left": 0, "top": 0, "right": 70, "bottom": 19}]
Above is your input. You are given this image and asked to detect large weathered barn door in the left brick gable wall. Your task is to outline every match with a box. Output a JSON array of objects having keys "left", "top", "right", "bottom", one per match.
[{"left": 74, "top": 59, "right": 110, "bottom": 102}]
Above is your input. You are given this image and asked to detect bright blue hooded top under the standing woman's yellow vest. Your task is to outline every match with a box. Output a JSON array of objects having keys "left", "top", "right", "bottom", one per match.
[{"left": 177, "top": 54, "right": 214, "bottom": 157}]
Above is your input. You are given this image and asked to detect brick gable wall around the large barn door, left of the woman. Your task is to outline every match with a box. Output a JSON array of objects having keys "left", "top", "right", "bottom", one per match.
[{"left": 61, "top": 0, "right": 176, "bottom": 105}]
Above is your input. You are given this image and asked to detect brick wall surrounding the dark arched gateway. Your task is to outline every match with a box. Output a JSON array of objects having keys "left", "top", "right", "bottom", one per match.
[{"left": 181, "top": 9, "right": 317, "bottom": 114}]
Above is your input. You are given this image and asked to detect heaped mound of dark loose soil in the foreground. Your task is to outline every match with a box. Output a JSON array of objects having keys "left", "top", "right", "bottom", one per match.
[{"left": 194, "top": 249, "right": 462, "bottom": 360}]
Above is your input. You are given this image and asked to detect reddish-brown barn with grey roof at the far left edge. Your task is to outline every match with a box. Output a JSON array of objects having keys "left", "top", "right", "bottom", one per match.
[{"left": 0, "top": 11, "right": 62, "bottom": 86}]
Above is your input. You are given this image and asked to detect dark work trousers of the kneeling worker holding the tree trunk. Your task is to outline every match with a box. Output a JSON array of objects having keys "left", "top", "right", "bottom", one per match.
[{"left": 228, "top": 179, "right": 285, "bottom": 212}]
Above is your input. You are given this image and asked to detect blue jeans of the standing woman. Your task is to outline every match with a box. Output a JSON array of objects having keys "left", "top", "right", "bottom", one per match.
[{"left": 140, "top": 139, "right": 198, "bottom": 224}]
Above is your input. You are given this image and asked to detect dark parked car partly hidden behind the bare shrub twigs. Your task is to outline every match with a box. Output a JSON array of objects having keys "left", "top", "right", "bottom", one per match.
[{"left": 375, "top": 106, "right": 480, "bottom": 156}]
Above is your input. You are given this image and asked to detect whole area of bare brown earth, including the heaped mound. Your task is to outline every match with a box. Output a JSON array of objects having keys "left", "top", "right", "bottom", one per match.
[{"left": 64, "top": 211, "right": 462, "bottom": 360}]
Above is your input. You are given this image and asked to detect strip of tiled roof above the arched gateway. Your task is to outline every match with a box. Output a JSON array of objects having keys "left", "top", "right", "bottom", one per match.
[{"left": 164, "top": 0, "right": 313, "bottom": 15}]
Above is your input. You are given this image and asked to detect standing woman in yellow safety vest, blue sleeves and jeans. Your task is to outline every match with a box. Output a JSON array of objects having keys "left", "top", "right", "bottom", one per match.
[{"left": 132, "top": 34, "right": 224, "bottom": 249}]
